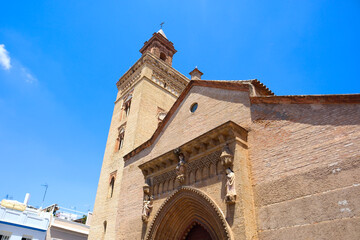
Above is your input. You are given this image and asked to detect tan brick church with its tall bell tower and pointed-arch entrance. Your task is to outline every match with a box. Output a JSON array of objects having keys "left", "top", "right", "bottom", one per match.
[{"left": 89, "top": 30, "right": 360, "bottom": 240}]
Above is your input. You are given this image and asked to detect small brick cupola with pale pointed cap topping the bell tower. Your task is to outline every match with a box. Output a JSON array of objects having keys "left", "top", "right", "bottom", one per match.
[{"left": 140, "top": 29, "right": 177, "bottom": 66}]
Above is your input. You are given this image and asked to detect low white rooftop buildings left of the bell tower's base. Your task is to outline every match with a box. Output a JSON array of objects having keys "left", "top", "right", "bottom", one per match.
[{"left": 0, "top": 194, "right": 91, "bottom": 240}]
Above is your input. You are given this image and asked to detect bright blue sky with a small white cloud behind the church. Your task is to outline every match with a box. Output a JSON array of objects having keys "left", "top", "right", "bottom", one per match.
[{"left": 0, "top": 0, "right": 360, "bottom": 211}]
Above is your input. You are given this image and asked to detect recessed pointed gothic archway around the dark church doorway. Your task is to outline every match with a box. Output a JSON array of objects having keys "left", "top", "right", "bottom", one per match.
[{"left": 146, "top": 187, "right": 233, "bottom": 240}]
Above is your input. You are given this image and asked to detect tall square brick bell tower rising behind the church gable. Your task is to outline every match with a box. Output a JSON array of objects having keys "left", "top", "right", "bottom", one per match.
[{"left": 89, "top": 29, "right": 189, "bottom": 240}]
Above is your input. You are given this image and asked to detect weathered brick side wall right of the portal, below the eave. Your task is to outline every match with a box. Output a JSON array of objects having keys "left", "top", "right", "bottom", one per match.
[{"left": 249, "top": 104, "right": 360, "bottom": 239}]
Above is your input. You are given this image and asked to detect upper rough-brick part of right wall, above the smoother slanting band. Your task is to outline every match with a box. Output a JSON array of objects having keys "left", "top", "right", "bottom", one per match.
[{"left": 249, "top": 104, "right": 360, "bottom": 183}]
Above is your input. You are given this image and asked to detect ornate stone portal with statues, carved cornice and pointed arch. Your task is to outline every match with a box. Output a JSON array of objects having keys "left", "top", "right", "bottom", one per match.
[{"left": 139, "top": 122, "right": 256, "bottom": 239}]
